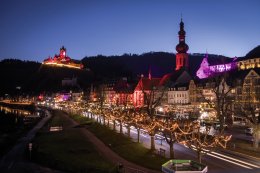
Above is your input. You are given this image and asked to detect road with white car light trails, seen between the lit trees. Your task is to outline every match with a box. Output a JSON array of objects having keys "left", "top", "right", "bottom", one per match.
[{"left": 87, "top": 113, "right": 260, "bottom": 173}]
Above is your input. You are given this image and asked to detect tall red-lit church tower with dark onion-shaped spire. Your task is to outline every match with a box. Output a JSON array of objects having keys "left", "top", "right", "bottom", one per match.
[{"left": 175, "top": 18, "right": 189, "bottom": 70}]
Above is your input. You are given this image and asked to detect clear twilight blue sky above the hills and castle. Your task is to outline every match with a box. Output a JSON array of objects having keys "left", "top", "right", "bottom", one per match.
[{"left": 0, "top": 0, "right": 260, "bottom": 62}]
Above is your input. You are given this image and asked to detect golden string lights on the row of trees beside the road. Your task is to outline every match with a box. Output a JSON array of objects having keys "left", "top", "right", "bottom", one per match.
[{"left": 85, "top": 104, "right": 231, "bottom": 163}]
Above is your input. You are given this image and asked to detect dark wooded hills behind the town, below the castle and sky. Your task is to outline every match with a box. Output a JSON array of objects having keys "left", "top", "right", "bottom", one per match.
[{"left": 0, "top": 46, "right": 260, "bottom": 96}]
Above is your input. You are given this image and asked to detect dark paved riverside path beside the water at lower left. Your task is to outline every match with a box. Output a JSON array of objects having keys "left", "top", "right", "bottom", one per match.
[{"left": 0, "top": 111, "right": 63, "bottom": 173}]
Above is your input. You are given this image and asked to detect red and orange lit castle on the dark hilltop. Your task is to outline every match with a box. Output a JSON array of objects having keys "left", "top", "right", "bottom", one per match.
[{"left": 42, "top": 46, "right": 83, "bottom": 69}]
